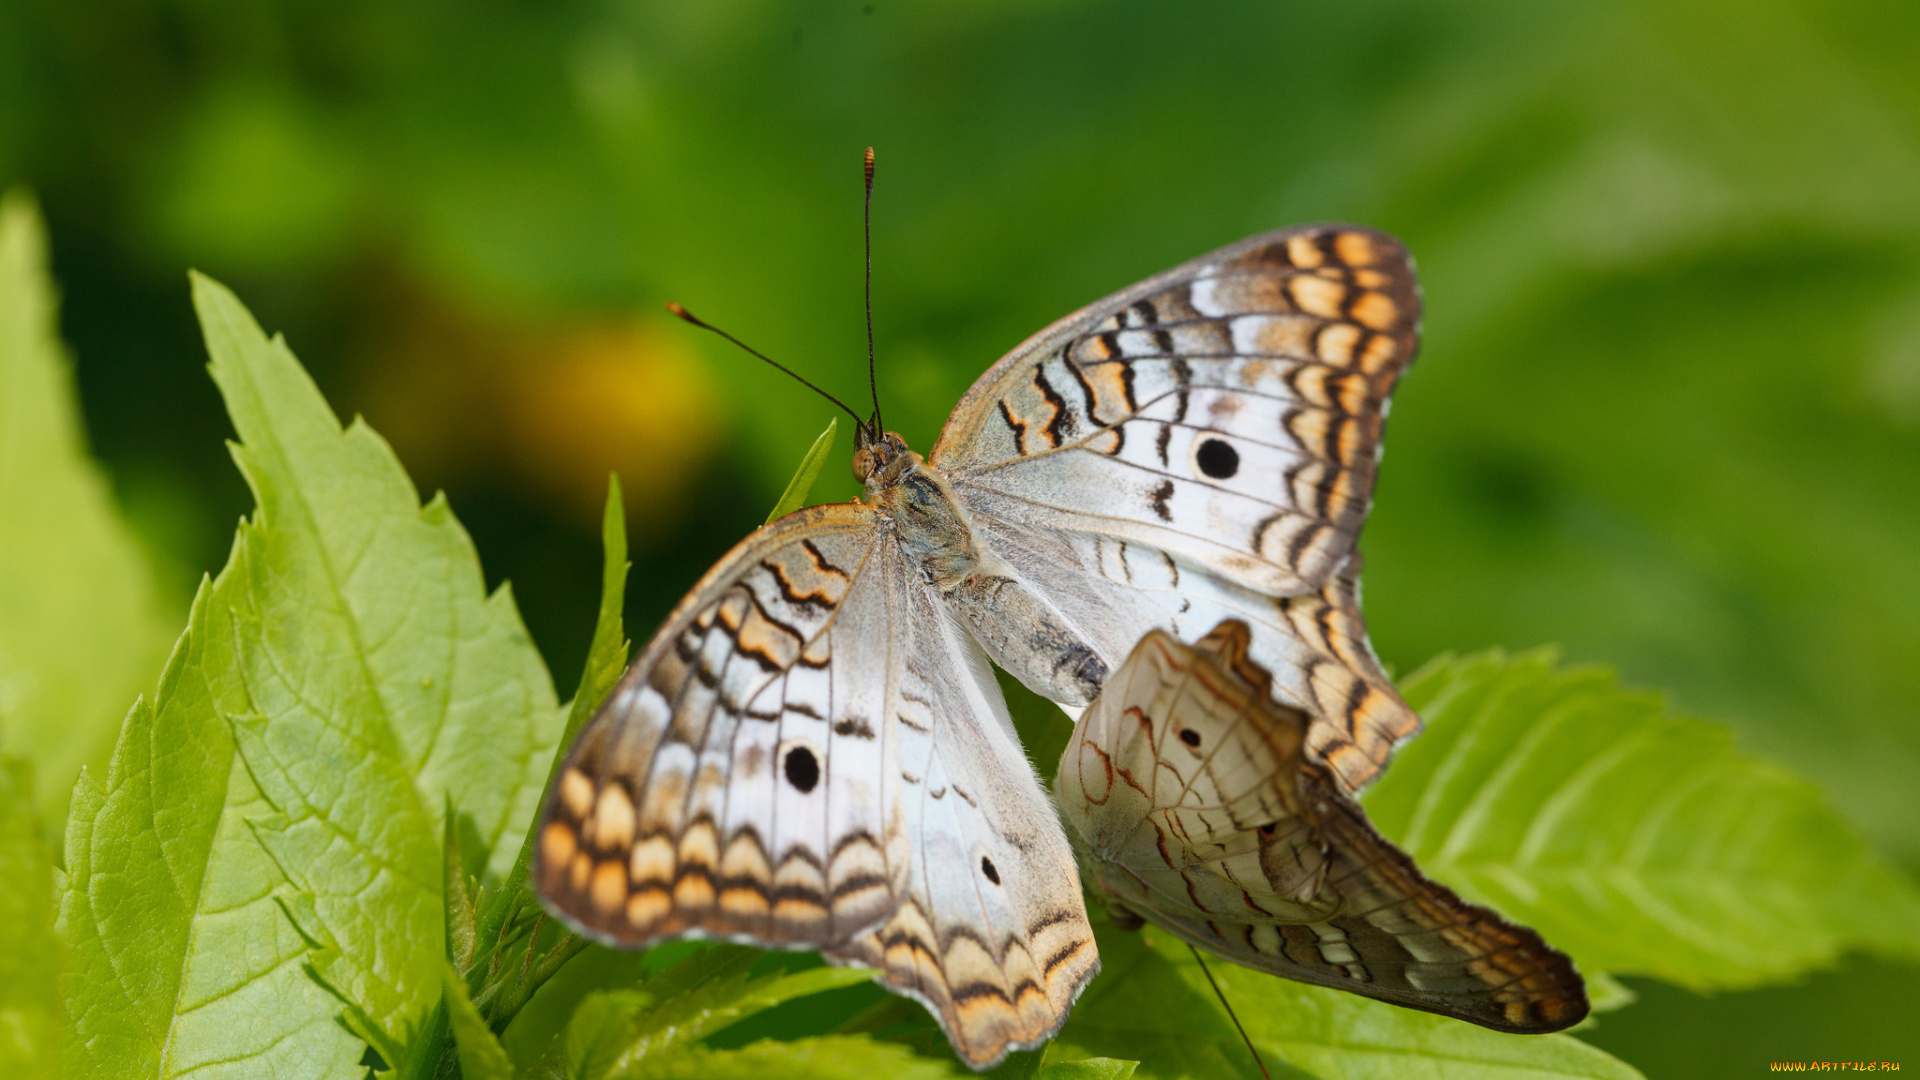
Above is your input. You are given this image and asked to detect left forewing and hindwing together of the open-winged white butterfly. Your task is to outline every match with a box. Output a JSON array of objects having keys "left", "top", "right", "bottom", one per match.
[{"left": 534, "top": 505, "right": 1098, "bottom": 1068}]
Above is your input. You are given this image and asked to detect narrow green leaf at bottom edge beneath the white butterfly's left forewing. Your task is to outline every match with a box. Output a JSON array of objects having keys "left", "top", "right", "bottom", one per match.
[{"left": 566, "top": 945, "right": 874, "bottom": 1076}]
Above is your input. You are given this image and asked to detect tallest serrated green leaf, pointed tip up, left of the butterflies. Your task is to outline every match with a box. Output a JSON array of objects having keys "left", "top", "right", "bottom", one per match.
[{"left": 194, "top": 275, "right": 561, "bottom": 1061}]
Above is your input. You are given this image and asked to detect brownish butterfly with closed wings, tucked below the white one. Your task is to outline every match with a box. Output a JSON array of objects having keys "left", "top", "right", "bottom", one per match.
[{"left": 1056, "top": 623, "right": 1588, "bottom": 1032}]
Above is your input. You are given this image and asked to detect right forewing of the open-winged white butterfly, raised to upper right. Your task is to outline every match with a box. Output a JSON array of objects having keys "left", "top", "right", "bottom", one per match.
[{"left": 929, "top": 225, "right": 1421, "bottom": 596}]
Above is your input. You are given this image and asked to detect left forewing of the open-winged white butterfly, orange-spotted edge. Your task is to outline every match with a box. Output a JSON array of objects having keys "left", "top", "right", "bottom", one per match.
[{"left": 534, "top": 505, "right": 906, "bottom": 947}]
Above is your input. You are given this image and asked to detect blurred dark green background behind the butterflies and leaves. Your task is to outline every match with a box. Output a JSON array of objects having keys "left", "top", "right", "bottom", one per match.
[{"left": 0, "top": 0, "right": 1920, "bottom": 1076}]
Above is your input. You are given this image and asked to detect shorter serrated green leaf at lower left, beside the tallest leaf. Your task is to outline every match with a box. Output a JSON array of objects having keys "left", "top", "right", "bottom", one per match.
[{"left": 60, "top": 576, "right": 365, "bottom": 1080}]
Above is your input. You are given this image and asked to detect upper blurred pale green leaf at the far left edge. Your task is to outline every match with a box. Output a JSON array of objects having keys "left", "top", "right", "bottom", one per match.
[{"left": 0, "top": 192, "right": 171, "bottom": 828}]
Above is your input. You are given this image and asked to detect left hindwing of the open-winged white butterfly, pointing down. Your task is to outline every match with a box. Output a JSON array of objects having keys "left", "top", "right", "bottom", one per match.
[{"left": 829, "top": 582, "right": 1100, "bottom": 1068}]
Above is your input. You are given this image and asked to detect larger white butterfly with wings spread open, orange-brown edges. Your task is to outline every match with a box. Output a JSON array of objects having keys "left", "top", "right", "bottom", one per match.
[{"left": 534, "top": 225, "right": 1419, "bottom": 1068}]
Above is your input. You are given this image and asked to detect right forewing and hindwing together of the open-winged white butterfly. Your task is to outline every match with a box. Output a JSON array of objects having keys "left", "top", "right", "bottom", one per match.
[{"left": 929, "top": 225, "right": 1419, "bottom": 792}]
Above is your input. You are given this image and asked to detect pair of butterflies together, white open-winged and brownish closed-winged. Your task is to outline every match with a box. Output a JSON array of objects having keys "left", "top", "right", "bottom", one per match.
[{"left": 536, "top": 225, "right": 1586, "bottom": 1068}]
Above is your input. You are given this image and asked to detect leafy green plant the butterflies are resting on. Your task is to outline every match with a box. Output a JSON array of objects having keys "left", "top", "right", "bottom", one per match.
[{"left": 11, "top": 202, "right": 1920, "bottom": 1080}]
